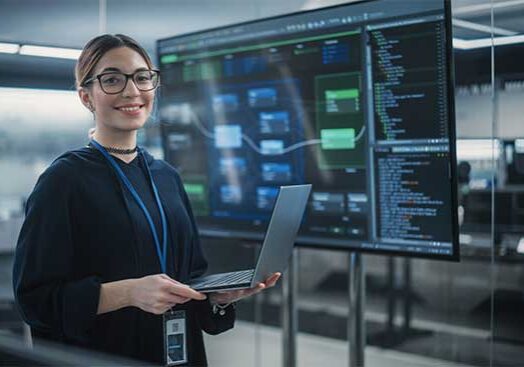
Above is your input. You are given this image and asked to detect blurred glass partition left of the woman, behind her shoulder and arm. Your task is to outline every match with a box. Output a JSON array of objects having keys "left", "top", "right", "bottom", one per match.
[{"left": 0, "top": 85, "right": 93, "bottom": 348}]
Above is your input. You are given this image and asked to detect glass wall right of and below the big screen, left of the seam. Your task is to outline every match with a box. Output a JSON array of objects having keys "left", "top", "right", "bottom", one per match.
[{"left": 290, "top": 0, "right": 496, "bottom": 366}]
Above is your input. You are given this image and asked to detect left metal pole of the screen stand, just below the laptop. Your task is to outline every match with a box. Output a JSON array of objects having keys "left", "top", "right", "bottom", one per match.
[{"left": 282, "top": 248, "right": 298, "bottom": 367}]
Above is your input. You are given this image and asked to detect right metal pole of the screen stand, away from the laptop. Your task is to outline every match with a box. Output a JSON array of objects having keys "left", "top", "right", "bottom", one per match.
[{"left": 348, "top": 252, "right": 366, "bottom": 367}]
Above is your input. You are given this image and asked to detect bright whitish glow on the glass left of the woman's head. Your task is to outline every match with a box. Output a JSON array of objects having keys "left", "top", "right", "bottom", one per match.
[{"left": 0, "top": 88, "right": 92, "bottom": 221}]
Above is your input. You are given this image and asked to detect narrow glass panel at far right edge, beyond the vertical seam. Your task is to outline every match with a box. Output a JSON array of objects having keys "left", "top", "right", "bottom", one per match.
[{"left": 491, "top": 2, "right": 524, "bottom": 366}]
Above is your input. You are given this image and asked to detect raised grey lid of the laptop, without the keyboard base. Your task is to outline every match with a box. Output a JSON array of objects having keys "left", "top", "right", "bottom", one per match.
[{"left": 251, "top": 184, "right": 311, "bottom": 286}]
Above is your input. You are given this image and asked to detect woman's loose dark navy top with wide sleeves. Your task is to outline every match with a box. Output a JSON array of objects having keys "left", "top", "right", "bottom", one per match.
[{"left": 13, "top": 147, "right": 235, "bottom": 366}]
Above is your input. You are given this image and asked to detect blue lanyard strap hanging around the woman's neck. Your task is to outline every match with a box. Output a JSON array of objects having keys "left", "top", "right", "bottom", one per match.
[{"left": 91, "top": 139, "right": 167, "bottom": 274}]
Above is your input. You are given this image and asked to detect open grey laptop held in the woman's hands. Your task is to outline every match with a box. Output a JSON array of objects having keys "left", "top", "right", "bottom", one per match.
[{"left": 188, "top": 184, "right": 311, "bottom": 293}]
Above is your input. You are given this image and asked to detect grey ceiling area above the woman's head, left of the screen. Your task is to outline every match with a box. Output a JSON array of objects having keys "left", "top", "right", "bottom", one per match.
[{"left": 0, "top": 0, "right": 305, "bottom": 51}]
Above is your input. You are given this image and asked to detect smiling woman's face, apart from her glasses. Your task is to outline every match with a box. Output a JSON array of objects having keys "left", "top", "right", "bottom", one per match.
[{"left": 81, "top": 47, "right": 155, "bottom": 132}]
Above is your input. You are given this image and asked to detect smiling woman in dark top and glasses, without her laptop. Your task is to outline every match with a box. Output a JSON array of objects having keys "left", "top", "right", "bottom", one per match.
[{"left": 13, "top": 35, "right": 280, "bottom": 366}]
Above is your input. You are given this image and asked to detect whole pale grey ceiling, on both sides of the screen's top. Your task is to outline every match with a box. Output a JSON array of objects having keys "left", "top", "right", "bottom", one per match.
[{"left": 0, "top": 0, "right": 524, "bottom": 53}]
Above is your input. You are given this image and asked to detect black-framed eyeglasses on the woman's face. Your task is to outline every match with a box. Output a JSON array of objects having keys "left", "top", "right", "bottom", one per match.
[{"left": 84, "top": 70, "right": 160, "bottom": 94}]
